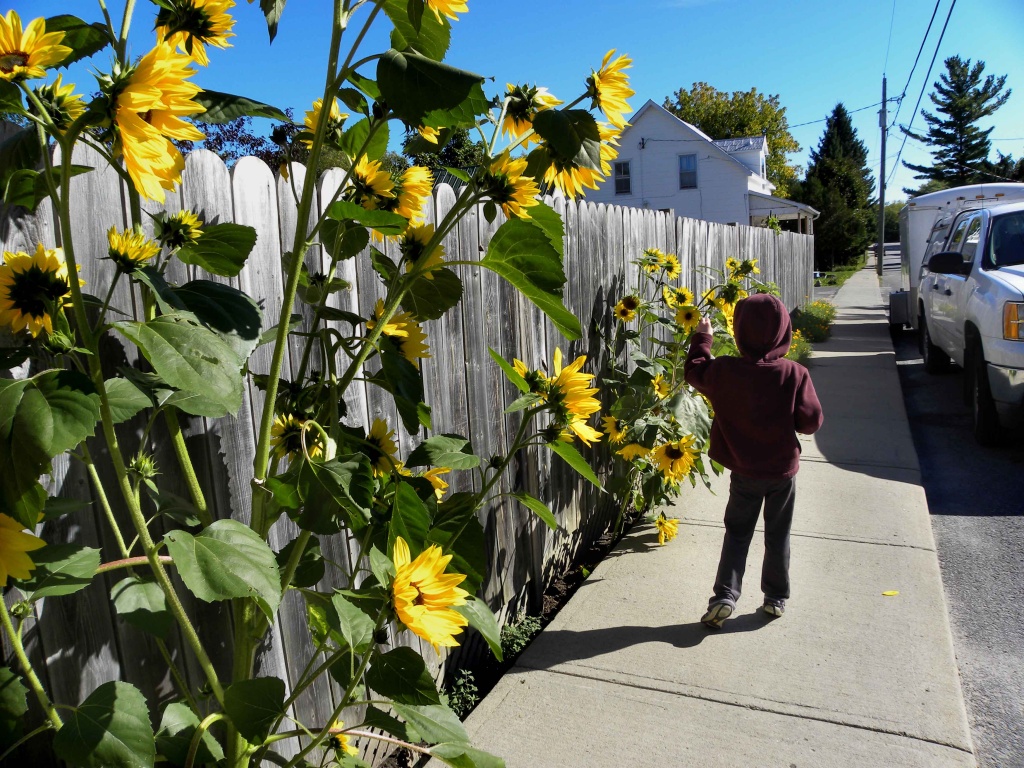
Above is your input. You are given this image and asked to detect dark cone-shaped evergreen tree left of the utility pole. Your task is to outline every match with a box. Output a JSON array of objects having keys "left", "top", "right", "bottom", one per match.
[{"left": 800, "top": 103, "right": 878, "bottom": 269}]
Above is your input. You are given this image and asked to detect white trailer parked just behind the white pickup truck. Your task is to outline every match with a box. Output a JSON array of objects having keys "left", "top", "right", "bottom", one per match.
[{"left": 889, "top": 187, "right": 1024, "bottom": 330}]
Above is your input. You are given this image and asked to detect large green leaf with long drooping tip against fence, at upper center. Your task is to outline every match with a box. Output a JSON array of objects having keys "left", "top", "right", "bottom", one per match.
[{"left": 480, "top": 219, "right": 583, "bottom": 339}]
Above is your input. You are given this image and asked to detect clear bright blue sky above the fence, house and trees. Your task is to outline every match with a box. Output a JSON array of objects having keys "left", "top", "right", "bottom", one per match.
[{"left": 4, "top": 0, "right": 1024, "bottom": 201}]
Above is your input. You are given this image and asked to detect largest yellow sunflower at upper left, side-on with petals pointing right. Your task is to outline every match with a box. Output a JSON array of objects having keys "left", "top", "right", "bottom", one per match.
[{"left": 104, "top": 44, "right": 206, "bottom": 203}]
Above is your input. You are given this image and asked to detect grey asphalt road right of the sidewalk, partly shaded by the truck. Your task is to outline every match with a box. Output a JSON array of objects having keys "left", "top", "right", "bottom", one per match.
[{"left": 872, "top": 256, "right": 1024, "bottom": 768}]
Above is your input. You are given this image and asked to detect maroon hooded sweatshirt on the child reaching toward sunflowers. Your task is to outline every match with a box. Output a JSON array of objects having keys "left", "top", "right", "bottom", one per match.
[{"left": 684, "top": 293, "right": 822, "bottom": 479}]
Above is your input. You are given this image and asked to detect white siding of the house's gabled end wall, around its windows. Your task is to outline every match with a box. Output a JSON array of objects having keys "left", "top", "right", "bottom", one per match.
[{"left": 587, "top": 104, "right": 760, "bottom": 224}]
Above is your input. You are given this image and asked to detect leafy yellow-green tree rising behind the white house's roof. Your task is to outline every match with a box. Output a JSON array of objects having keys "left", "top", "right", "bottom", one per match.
[{"left": 664, "top": 82, "right": 800, "bottom": 198}]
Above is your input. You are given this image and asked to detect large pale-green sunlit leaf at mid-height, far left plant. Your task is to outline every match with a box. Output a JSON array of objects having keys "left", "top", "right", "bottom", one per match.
[{"left": 114, "top": 312, "right": 243, "bottom": 418}]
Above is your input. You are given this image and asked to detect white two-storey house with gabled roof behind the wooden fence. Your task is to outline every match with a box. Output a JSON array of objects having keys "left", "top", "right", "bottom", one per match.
[{"left": 587, "top": 99, "right": 818, "bottom": 233}]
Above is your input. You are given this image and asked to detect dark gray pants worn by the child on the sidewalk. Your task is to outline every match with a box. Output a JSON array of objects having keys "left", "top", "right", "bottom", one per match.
[{"left": 711, "top": 472, "right": 797, "bottom": 605}]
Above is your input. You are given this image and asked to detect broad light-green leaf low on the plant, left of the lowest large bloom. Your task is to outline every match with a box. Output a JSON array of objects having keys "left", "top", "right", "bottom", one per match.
[{"left": 164, "top": 520, "right": 281, "bottom": 622}]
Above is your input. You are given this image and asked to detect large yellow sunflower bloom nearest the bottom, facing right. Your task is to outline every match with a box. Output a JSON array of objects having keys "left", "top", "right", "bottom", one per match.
[{"left": 391, "top": 536, "right": 469, "bottom": 651}]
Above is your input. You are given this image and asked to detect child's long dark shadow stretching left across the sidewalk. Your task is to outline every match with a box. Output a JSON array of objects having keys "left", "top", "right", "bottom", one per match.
[{"left": 518, "top": 609, "right": 774, "bottom": 670}]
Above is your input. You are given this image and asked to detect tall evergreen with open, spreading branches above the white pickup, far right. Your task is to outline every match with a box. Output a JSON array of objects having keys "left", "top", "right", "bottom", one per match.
[{"left": 903, "top": 56, "right": 1012, "bottom": 186}]
